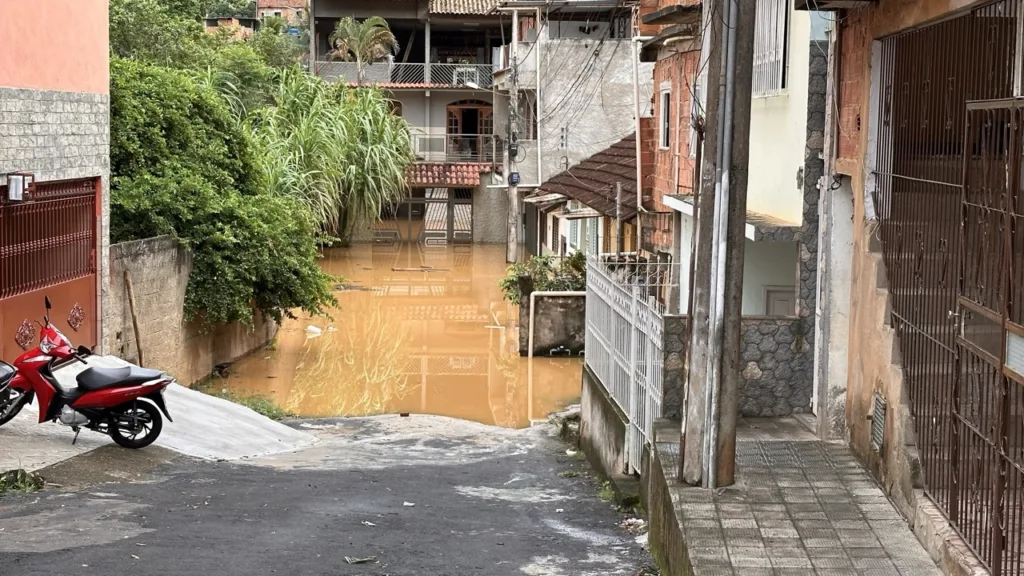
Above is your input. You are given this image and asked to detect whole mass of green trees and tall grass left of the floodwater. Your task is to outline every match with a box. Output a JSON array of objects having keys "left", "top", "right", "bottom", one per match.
[{"left": 110, "top": 0, "right": 412, "bottom": 326}]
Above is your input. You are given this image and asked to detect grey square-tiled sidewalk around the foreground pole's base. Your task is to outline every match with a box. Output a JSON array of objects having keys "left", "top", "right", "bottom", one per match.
[{"left": 657, "top": 419, "right": 942, "bottom": 576}]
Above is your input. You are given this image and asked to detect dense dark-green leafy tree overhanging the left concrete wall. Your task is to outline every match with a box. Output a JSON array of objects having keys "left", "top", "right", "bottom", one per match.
[{"left": 111, "top": 58, "right": 333, "bottom": 324}]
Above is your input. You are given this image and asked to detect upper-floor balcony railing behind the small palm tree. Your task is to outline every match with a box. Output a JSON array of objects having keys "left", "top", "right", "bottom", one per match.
[{"left": 316, "top": 60, "right": 494, "bottom": 90}]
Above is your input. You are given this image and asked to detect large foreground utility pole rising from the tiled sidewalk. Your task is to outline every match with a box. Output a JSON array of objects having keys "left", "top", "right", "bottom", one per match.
[{"left": 679, "top": 0, "right": 756, "bottom": 489}]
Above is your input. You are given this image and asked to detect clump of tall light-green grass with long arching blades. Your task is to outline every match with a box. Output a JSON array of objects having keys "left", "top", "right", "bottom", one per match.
[{"left": 249, "top": 69, "right": 414, "bottom": 240}]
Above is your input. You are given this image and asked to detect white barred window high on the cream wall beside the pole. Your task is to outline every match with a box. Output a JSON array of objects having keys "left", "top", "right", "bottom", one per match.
[{"left": 753, "top": 0, "right": 790, "bottom": 96}]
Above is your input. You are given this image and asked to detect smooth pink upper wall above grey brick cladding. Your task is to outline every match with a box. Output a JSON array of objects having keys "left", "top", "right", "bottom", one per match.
[{"left": 0, "top": 0, "right": 109, "bottom": 94}]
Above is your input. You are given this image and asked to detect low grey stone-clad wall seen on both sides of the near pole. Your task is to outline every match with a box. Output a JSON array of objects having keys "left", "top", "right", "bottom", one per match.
[{"left": 662, "top": 316, "right": 814, "bottom": 419}]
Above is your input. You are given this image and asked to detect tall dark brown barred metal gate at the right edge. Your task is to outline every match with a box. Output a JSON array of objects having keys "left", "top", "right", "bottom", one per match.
[{"left": 873, "top": 0, "right": 1024, "bottom": 576}]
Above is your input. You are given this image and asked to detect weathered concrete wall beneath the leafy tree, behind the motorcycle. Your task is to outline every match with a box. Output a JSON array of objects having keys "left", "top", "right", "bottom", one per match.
[{"left": 104, "top": 236, "right": 278, "bottom": 385}]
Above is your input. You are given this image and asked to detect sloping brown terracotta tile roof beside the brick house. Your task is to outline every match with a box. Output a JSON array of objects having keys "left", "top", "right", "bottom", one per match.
[{"left": 538, "top": 133, "right": 637, "bottom": 219}]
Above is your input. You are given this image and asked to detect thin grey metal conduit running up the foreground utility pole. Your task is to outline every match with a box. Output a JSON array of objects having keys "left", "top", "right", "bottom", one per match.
[{"left": 705, "top": 0, "right": 739, "bottom": 490}]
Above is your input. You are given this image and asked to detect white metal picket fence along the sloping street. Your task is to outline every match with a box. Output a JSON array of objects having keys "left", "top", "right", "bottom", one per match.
[{"left": 586, "top": 255, "right": 678, "bottom": 472}]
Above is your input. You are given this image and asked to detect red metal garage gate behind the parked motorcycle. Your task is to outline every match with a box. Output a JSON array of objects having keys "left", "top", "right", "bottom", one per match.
[{"left": 0, "top": 178, "right": 100, "bottom": 362}]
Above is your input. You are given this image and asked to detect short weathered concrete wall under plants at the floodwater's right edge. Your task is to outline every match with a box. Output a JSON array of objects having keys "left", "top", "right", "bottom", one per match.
[{"left": 519, "top": 296, "right": 587, "bottom": 356}]
